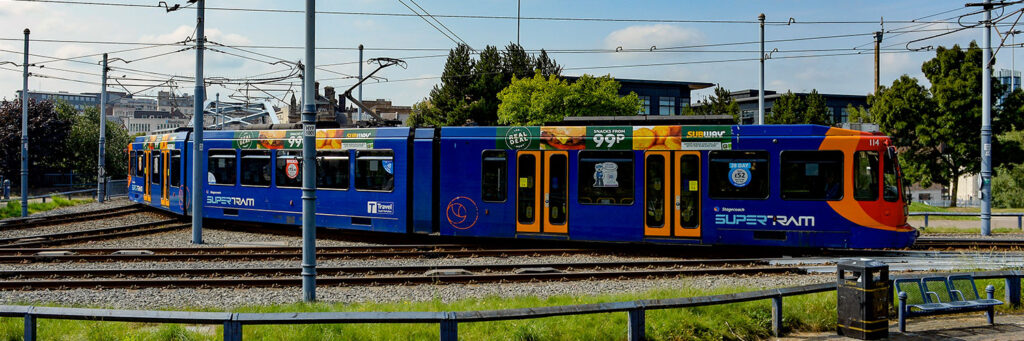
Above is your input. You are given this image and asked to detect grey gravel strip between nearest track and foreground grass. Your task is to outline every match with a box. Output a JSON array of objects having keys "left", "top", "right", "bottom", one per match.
[{"left": 0, "top": 274, "right": 836, "bottom": 310}]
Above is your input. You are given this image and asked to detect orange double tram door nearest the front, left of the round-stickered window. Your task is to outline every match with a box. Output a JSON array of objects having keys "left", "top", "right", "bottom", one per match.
[{"left": 644, "top": 151, "right": 700, "bottom": 238}]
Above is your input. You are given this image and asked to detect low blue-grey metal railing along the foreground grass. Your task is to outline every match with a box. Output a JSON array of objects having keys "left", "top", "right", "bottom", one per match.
[{"left": 0, "top": 270, "right": 1024, "bottom": 341}]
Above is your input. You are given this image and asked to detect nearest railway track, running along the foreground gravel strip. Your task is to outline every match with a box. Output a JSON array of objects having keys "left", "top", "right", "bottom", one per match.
[{"left": 0, "top": 260, "right": 805, "bottom": 290}]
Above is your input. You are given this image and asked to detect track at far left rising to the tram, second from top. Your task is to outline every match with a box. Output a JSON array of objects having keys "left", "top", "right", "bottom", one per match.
[{"left": 0, "top": 219, "right": 190, "bottom": 248}]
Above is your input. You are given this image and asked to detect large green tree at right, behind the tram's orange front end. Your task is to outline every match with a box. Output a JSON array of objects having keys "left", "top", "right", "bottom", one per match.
[{"left": 871, "top": 42, "right": 1007, "bottom": 205}]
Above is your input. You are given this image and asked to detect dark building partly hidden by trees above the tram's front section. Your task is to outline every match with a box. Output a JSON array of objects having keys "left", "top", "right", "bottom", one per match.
[{"left": 730, "top": 89, "right": 867, "bottom": 124}]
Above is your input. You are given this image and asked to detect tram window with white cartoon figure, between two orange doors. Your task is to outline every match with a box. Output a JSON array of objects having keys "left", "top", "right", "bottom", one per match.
[{"left": 577, "top": 151, "right": 634, "bottom": 205}]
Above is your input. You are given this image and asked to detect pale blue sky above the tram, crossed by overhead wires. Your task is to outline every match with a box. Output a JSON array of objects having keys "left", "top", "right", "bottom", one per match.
[{"left": 0, "top": 0, "right": 1011, "bottom": 105}]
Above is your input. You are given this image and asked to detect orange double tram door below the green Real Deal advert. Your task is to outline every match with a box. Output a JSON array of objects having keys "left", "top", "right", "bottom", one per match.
[{"left": 516, "top": 151, "right": 569, "bottom": 233}]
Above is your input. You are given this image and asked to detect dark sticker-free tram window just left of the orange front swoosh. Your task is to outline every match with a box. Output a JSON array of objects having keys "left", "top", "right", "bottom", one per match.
[{"left": 780, "top": 151, "right": 844, "bottom": 201}]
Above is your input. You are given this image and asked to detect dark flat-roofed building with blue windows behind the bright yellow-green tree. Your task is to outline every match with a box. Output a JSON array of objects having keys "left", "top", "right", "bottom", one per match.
[{"left": 562, "top": 76, "right": 715, "bottom": 116}]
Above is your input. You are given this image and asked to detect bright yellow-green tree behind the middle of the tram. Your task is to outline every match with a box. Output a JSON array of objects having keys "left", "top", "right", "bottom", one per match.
[{"left": 498, "top": 73, "right": 640, "bottom": 126}]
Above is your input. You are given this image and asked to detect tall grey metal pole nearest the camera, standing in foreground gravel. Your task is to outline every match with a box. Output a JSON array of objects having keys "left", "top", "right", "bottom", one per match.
[{"left": 302, "top": 0, "right": 315, "bottom": 302}]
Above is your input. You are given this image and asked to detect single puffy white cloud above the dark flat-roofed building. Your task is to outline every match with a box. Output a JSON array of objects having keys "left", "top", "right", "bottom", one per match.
[{"left": 604, "top": 24, "right": 705, "bottom": 49}]
